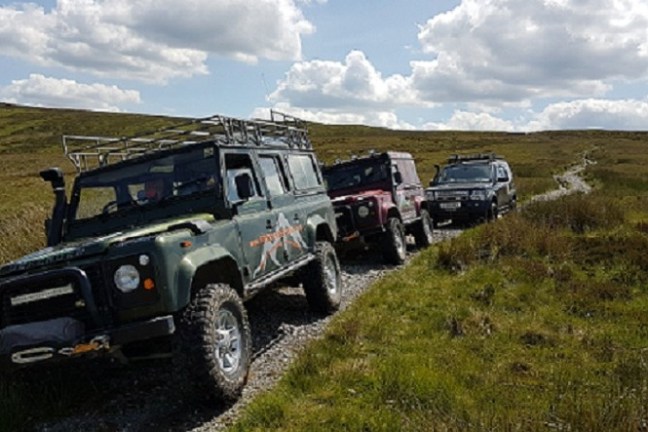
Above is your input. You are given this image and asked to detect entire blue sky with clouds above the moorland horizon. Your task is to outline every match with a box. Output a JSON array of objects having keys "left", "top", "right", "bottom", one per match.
[{"left": 0, "top": 0, "right": 648, "bottom": 132}]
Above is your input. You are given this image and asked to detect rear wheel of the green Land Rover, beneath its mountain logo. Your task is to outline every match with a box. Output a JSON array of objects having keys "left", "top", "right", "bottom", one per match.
[{"left": 302, "top": 242, "right": 342, "bottom": 313}]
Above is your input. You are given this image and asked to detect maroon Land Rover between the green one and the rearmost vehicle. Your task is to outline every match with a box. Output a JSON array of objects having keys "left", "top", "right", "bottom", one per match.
[{"left": 324, "top": 152, "right": 433, "bottom": 264}]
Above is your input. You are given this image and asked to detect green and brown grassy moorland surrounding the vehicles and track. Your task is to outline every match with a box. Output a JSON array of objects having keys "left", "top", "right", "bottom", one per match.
[{"left": 0, "top": 106, "right": 648, "bottom": 431}]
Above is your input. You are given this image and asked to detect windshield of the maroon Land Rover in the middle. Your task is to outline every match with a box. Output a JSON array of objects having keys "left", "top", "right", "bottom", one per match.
[{"left": 324, "top": 159, "right": 391, "bottom": 191}]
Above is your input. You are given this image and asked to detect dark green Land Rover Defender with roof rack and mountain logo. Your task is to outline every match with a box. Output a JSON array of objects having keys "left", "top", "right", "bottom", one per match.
[{"left": 0, "top": 112, "right": 342, "bottom": 400}]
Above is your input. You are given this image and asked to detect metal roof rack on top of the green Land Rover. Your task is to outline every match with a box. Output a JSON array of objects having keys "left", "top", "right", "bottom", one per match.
[{"left": 63, "top": 110, "right": 312, "bottom": 172}]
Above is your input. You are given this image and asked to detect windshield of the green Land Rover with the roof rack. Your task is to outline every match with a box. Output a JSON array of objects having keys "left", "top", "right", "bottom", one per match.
[{"left": 70, "top": 147, "right": 218, "bottom": 222}]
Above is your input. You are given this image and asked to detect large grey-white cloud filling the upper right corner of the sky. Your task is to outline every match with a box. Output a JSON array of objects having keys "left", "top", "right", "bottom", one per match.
[{"left": 412, "top": 0, "right": 648, "bottom": 103}]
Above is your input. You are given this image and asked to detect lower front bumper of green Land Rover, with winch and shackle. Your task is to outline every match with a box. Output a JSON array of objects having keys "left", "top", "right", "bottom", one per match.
[{"left": 0, "top": 315, "right": 175, "bottom": 370}]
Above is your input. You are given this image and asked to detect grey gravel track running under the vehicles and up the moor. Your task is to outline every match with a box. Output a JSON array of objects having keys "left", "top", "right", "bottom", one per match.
[{"left": 36, "top": 159, "right": 592, "bottom": 432}]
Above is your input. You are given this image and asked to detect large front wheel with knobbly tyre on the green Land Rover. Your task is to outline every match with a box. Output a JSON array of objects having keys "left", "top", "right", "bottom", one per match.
[{"left": 178, "top": 284, "right": 252, "bottom": 402}]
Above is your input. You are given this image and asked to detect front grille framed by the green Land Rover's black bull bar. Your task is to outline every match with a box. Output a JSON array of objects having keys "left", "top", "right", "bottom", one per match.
[{"left": 0, "top": 269, "right": 93, "bottom": 328}]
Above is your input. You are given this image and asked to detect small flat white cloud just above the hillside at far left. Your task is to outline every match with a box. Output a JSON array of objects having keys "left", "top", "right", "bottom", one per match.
[{"left": 0, "top": 74, "right": 140, "bottom": 111}]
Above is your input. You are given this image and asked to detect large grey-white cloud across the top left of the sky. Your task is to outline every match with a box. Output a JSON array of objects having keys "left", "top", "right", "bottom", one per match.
[{"left": 0, "top": 0, "right": 314, "bottom": 83}]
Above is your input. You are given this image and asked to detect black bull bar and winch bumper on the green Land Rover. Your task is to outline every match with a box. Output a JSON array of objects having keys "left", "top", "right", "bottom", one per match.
[{"left": 0, "top": 267, "right": 175, "bottom": 370}]
